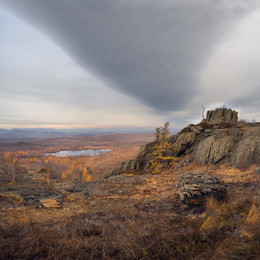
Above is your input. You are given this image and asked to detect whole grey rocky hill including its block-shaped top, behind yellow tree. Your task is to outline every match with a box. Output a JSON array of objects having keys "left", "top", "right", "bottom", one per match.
[{"left": 104, "top": 108, "right": 260, "bottom": 177}]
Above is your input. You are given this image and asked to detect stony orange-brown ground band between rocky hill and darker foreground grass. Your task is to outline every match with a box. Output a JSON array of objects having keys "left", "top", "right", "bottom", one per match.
[{"left": 0, "top": 164, "right": 260, "bottom": 224}]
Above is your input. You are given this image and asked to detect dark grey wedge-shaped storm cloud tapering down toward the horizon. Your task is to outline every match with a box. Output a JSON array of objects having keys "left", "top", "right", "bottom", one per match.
[{"left": 0, "top": 0, "right": 257, "bottom": 111}]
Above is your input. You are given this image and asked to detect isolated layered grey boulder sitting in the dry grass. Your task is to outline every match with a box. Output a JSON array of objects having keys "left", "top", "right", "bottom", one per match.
[{"left": 176, "top": 173, "right": 227, "bottom": 206}]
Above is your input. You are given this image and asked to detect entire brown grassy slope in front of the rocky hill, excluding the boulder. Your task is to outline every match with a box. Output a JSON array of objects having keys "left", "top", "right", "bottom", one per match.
[{"left": 0, "top": 164, "right": 260, "bottom": 259}]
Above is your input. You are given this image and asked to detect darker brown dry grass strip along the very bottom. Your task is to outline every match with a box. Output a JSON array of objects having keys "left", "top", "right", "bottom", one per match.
[{"left": 0, "top": 192, "right": 260, "bottom": 259}]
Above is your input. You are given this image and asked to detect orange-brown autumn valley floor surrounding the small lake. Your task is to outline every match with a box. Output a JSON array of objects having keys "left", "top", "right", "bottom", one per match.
[{"left": 2, "top": 133, "right": 153, "bottom": 181}]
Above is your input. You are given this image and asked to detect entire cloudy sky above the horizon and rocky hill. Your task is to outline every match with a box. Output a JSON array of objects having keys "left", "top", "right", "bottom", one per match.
[{"left": 0, "top": 0, "right": 260, "bottom": 128}]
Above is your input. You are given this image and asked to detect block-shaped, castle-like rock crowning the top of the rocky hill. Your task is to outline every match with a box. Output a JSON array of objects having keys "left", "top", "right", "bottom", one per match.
[{"left": 206, "top": 108, "right": 238, "bottom": 125}]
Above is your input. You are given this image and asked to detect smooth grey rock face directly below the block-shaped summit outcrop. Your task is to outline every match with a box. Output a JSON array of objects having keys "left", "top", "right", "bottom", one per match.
[{"left": 185, "top": 122, "right": 260, "bottom": 165}]
